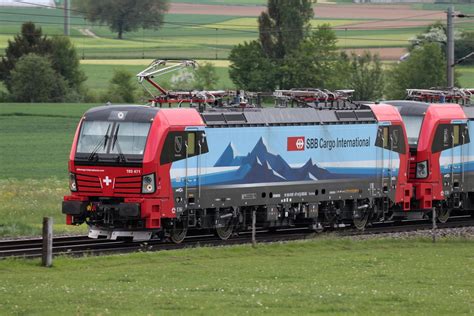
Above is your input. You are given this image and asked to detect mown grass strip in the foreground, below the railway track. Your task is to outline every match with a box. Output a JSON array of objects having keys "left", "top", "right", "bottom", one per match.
[{"left": 0, "top": 239, "right": 474, "bottom": 315}]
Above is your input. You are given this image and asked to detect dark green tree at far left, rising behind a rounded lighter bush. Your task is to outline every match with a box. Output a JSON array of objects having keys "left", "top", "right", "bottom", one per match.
[{"left": 0, "top": 22, "right": 86, "bottom": 94}]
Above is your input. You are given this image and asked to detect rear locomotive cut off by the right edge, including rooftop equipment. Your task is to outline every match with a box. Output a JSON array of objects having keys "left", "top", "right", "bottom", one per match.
[{"left": 386, "top": 95, "right": 474, "bottom": 223}]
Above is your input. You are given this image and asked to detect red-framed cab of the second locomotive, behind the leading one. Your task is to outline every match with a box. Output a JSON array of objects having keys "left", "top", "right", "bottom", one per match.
[{"left": 387, "top": 101, "right": 470, "bottom": 217}]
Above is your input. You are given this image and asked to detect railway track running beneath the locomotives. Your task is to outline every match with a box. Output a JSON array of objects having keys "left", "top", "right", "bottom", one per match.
[{"left": 0, "top": 218, "right": 474, "bottom": 258}]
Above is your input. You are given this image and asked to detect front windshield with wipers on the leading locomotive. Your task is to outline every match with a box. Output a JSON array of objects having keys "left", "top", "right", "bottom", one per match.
[{"left": 77, "top": 121, "right": 151, "bottom": 155}]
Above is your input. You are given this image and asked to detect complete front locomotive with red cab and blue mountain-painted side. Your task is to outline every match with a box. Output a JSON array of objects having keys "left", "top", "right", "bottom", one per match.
[{"left": 62, "top": 100, "right": 412, "bottom": 242}]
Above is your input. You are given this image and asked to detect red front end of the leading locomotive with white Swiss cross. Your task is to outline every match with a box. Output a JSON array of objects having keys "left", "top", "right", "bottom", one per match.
[{"left": 62, "top": 106, "right": 203, "bottom": 240}]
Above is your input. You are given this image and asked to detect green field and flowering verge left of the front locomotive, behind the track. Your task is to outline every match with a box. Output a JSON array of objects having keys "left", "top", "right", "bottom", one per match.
[{"left": 0, "top": 104, "right": 92, "bottom": 236}]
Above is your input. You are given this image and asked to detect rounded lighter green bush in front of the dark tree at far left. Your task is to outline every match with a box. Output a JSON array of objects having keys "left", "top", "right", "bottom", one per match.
[{"left": 11, "top": 53, "right": 68, "bottom": 102}]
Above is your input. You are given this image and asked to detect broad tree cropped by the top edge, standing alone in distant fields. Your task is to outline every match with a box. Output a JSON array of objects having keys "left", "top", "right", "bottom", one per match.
[{"left": 77, "top": 0, "right": 169, "bottom": 39}]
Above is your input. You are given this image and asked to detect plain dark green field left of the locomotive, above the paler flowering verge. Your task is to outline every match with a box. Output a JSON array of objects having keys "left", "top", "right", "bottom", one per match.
[{"left": 0, "top": 104, "right": 91, "bottom": 179}]
